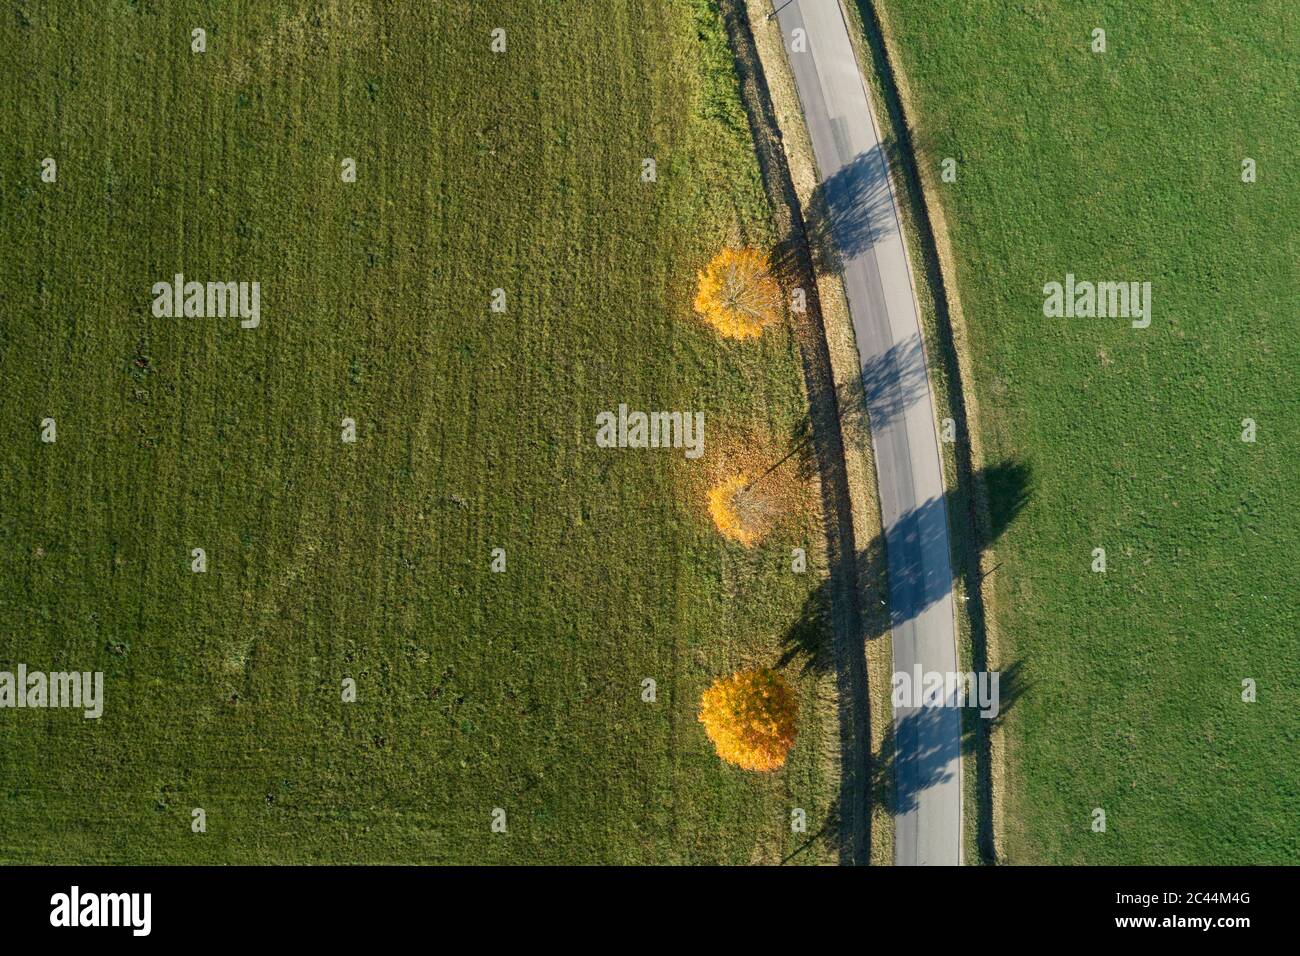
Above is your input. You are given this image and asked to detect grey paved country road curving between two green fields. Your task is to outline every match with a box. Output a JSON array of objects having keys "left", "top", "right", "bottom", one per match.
[{"left": 775, "top": 0, "right": 962, "bottom": 865}]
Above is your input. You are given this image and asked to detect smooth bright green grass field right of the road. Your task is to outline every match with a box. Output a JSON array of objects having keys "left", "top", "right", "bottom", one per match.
[{"left": 881, "top": 0, "right": 1300, "bottom": 864}]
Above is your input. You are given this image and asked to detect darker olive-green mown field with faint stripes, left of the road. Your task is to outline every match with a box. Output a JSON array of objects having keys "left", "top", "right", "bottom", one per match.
[{"left": 0, "top": 0, "right": 837, "bottom": 862}]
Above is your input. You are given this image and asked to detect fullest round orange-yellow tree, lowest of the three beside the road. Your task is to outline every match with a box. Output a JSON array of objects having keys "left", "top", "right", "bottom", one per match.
[{"left": 699, "top": 667, "right": 798, "bottom": 770}]
